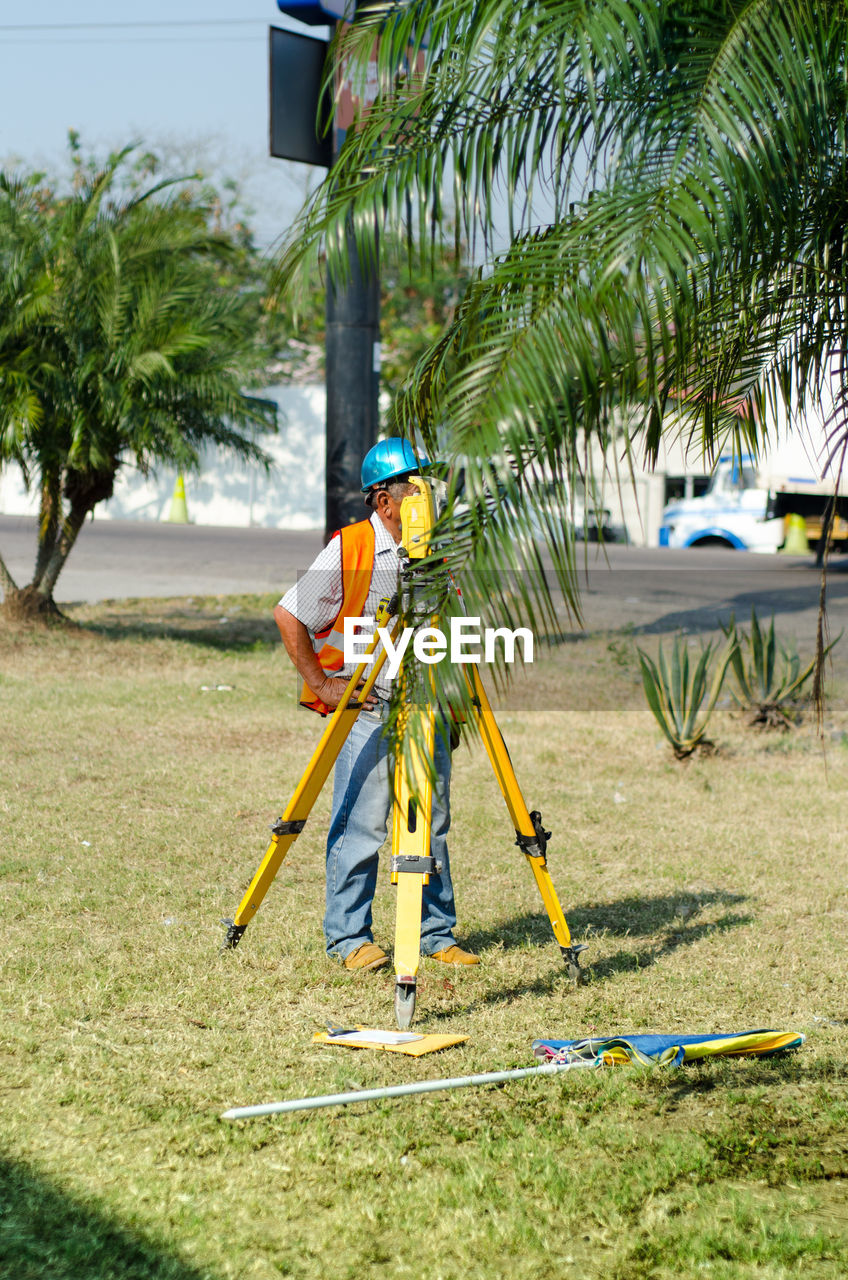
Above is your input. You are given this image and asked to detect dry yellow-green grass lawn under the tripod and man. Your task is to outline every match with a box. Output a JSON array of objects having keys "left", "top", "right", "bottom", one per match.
[{"left": 0, "top": 596, "right": 848, "bottom": 1280}]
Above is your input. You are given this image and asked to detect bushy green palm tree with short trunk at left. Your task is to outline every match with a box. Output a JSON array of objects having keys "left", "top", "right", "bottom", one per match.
[{"left": 0, "top": 148, "right": 273, "bottom": 616}]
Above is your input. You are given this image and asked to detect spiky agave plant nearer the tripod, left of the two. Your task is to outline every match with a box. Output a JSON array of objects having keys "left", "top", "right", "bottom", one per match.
[{"left": 637, "top": 635, "right": 737, "bottom": 760}]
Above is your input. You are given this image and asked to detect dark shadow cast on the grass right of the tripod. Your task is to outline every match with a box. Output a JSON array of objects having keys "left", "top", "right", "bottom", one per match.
[{"left": 450, "top": 890, "right": 753, "bottom": 1004}]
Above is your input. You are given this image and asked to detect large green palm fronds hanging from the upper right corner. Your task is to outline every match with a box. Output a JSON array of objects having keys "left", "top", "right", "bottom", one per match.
[{"left": 279, "top": 0, "right": 848, "bottom": 675}]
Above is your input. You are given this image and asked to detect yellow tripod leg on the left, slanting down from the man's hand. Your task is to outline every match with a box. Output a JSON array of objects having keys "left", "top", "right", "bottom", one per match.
[{"left": 222, "top": 614, "right": 398, "bottom": 951}]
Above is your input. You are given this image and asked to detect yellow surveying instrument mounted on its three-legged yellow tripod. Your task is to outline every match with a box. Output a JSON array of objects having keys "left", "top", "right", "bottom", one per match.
[{"left": 222, "top": 475, "right": 585, "bottom": 1030}]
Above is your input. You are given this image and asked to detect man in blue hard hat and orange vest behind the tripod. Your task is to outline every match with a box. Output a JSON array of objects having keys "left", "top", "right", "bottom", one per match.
[{"left": 274, "top": 436, "right": 479, "bottom": 969}]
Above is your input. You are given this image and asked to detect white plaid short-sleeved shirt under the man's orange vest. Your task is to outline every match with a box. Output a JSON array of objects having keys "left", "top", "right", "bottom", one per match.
[{"left": 279, "top": 512, "right": 398, "bottom": 698}]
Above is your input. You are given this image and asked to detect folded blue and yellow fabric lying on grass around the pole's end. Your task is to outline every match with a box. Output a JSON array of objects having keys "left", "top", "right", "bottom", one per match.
[{"left": 533, "top": 1030, "right": 806, "bottom": 1066}]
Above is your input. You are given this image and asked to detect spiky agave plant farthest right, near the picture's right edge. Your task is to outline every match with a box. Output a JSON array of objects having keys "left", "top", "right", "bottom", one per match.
[{"left": 722, "top": 608, "right": 842, "bottom": 730}]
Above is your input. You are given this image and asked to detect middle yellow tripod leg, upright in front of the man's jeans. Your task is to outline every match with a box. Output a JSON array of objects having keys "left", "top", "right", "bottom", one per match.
[{"left": 392, "top": 707, "right": 438, "bottom": 1030}]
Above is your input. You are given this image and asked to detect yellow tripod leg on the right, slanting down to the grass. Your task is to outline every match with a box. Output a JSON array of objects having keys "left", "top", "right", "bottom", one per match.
[{"left": 465, "top": 667, "right": 585, "bottom": 983}]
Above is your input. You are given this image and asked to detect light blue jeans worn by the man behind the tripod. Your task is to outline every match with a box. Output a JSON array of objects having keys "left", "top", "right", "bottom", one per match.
[{"left": 324, "top": 703, "right": 456, "bottom": 960}]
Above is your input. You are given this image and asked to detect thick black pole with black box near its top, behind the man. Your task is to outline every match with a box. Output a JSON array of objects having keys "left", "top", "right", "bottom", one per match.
[{"left": 272, "top": 0, "right": 380, "bottom": 539}]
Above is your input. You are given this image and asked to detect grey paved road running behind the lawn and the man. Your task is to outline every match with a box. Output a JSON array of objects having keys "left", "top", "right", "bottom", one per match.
[{"left": 0, "top": 516, "right": 848, "bottom": 641}]
